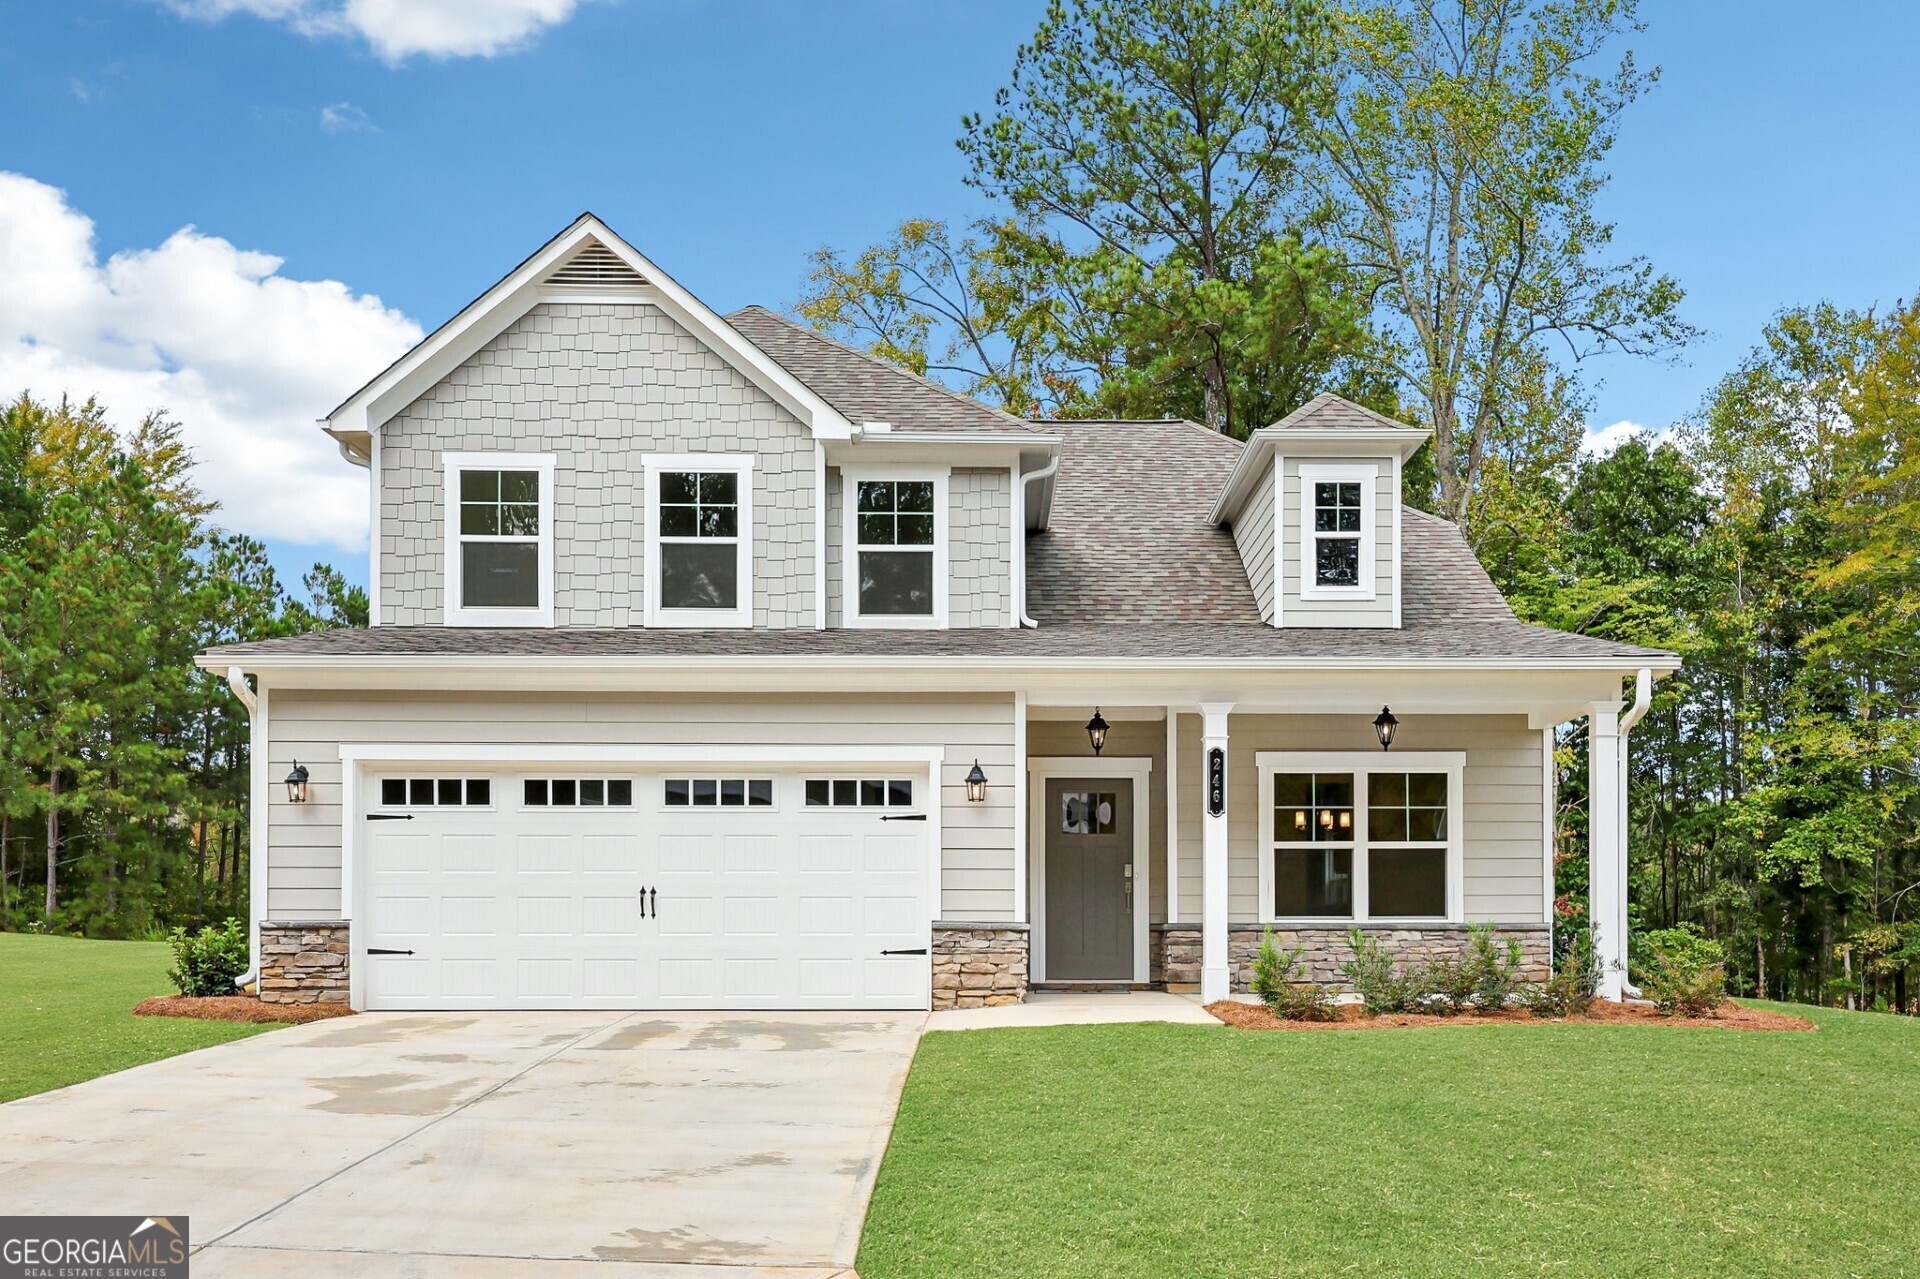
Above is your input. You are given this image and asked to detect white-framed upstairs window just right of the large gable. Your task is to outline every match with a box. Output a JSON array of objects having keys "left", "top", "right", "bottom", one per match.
[{"left": 843, "top": 471, "right": 947, "bottom": 626}]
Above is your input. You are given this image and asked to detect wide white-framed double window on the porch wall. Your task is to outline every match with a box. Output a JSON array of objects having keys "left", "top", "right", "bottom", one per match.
[{"left": 1256, "top": 751, "right": 1465, "bottom": 922}]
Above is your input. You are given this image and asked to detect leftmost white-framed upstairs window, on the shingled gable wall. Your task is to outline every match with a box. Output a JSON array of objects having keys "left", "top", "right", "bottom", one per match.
[{"left": 442, "top": 453, "right": 553, "bottom": 626}]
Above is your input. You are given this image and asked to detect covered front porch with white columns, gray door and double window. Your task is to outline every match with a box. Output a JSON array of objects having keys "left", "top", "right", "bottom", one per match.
[{"left": 933, "top": 676, "right": 1644, "bottom": 1010}]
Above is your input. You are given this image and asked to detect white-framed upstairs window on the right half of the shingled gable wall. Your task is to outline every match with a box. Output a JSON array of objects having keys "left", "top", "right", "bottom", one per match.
[{"left": 645, "top": 453, "right": 753, "bottom": 626}]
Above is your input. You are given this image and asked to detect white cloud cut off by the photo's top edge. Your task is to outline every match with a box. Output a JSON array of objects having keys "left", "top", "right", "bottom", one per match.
[{"left": 163, "top": 0, "right": 580, "bottom": 63}]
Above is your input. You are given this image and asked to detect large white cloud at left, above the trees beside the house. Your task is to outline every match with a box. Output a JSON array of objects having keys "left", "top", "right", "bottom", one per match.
[{"left": 0, "top": 173, "right": 420, "bottom": 549}]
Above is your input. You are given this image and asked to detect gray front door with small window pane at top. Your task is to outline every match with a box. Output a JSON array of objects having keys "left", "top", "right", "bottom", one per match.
[{"left": 1044, "top": 778, "right": 1144, "bottom": 981}]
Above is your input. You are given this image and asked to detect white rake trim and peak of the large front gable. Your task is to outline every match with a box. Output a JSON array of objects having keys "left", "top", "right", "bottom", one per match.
[{"left": 321, "top": 213, "right": 852, "bottom": 442}]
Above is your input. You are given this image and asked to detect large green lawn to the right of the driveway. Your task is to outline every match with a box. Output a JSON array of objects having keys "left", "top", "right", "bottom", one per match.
[{"left": 860, "top": 1008, "right": 1920, "bottom": 1279}]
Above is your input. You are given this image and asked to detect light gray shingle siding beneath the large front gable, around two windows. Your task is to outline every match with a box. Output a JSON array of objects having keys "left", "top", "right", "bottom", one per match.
[{"left": 380, "top": 303, "right": 814, "bottom": 628}]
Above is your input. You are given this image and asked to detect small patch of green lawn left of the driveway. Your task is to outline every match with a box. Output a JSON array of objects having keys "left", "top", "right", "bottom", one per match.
[{"left": 0, "top": 933, "right": 275, "bottom": 1102}]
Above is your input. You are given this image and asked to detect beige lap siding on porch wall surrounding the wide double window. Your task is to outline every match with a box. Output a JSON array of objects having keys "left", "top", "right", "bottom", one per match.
[{"left": 1179, "top": 714, "right": 1548, "bottom": 924}]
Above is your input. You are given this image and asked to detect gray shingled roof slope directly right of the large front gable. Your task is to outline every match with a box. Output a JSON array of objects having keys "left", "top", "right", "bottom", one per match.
[{"left": 726, "top": 305, "right": 1048, "bottom": 444}]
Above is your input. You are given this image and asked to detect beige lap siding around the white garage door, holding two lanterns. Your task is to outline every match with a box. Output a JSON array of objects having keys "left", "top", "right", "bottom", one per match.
[{"left": 267, "top": 691, "right": 1014, "bottom": 920}]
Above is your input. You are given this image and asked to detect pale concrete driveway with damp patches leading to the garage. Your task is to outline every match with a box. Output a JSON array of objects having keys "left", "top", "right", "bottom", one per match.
[{"left": 0, "top": 1012, "right": 925, "bottom": 1279}]
